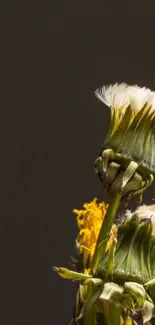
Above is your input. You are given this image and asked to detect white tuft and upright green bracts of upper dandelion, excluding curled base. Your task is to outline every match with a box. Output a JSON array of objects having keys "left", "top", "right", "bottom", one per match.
[{"left": 95, "top": 83, "right": 155, "bottom": 174}]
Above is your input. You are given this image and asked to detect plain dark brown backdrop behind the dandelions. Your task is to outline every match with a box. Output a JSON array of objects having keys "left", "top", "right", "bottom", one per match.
[{"left": 0, "top": 1, "right": 155, "bottom": 325}]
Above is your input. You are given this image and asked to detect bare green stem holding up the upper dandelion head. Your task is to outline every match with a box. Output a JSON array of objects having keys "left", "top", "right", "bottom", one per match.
[{"left": 91, "top": 192, "right": 122, "bottom": 274}]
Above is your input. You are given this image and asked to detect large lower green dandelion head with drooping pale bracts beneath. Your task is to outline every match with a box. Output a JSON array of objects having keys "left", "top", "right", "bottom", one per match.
[{"left": 89, "top": 205, "right": 155, "bottom": 324}]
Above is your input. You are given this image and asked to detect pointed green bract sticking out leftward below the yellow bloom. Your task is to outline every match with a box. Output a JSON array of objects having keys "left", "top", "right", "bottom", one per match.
[{"left": 53, "top": 266, "right": 92, "bottom": 281}]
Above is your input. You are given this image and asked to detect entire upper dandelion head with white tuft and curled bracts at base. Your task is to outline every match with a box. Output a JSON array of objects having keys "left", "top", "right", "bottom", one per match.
[{"left": 95, "top": 83, "right": 155, "bottom": 196}]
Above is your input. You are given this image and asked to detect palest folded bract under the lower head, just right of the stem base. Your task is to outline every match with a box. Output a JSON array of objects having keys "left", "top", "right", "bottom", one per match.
[{"left": 100, "top": 282, "right": 124, "bottom": 300}]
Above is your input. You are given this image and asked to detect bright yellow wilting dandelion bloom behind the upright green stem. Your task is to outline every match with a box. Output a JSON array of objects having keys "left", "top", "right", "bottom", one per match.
[{"left": 73, "top": 198, "right": 117, "bottom": 268}]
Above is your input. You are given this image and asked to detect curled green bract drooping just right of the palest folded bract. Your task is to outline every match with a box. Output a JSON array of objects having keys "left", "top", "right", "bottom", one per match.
[{"left": 124, "top": 282, "right": 146, "bottom": 308}]
